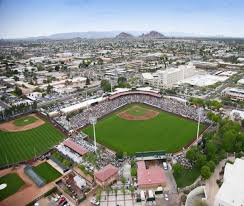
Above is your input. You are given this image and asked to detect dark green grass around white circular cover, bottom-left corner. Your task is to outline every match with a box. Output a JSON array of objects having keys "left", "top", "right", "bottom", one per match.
[{"left": 0, "top": 173, "right": 25, "bottom": 200}]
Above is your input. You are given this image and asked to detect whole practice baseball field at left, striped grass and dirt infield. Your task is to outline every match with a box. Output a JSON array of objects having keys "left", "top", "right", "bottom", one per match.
[{"left": 0, "top": 114, "right": 64, "bottom": 165}]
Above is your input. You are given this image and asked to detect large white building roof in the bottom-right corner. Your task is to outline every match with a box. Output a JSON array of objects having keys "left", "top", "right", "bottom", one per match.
[{"left": 214, "top": 158, "right": 244, "bottom": 206}]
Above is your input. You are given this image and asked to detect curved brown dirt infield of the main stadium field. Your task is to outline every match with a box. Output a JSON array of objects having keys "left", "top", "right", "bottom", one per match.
[{"left": 117, "top": 110, "right": 159, "bottom": 121}]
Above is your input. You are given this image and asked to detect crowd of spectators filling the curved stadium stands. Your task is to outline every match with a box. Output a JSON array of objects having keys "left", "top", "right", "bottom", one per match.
[{"left": 55, "top": 94, "right": 205, "bottom": 131}]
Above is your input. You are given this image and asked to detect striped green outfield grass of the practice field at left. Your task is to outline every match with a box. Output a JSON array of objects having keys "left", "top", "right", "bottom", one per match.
[{"left": 0, "top": 118, "right": 64, "bottom": 165}]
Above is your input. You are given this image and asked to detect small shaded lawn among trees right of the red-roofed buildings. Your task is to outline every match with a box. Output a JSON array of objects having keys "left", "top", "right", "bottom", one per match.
[{"left": 174, "top": 167, "right": 200, "bottom": 188}]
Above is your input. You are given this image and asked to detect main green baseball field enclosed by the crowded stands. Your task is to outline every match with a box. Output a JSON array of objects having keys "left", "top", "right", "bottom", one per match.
[{"left": 83, "top": 104, "right": 204, "bottom": 155}]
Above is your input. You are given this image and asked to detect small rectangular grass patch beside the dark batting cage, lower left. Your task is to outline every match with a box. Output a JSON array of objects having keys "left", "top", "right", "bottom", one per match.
[{"left": 33, "top": 162, "right": 62, "bottom": 183}]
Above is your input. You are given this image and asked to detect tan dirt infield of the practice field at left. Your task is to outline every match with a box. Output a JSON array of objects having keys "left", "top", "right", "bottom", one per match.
[{"left": 0, "top": 114, "right": 45, "bottom": 132}]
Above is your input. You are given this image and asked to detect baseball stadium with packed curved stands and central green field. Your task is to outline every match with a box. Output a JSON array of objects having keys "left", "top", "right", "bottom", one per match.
[{"left": 66, "top": 91, "right": 206, "bottom": 155}]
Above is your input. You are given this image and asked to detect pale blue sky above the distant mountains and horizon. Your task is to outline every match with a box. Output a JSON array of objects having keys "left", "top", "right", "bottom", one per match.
[{"left": 0, "top": 0, "right": 244, "bottom": 38}]
